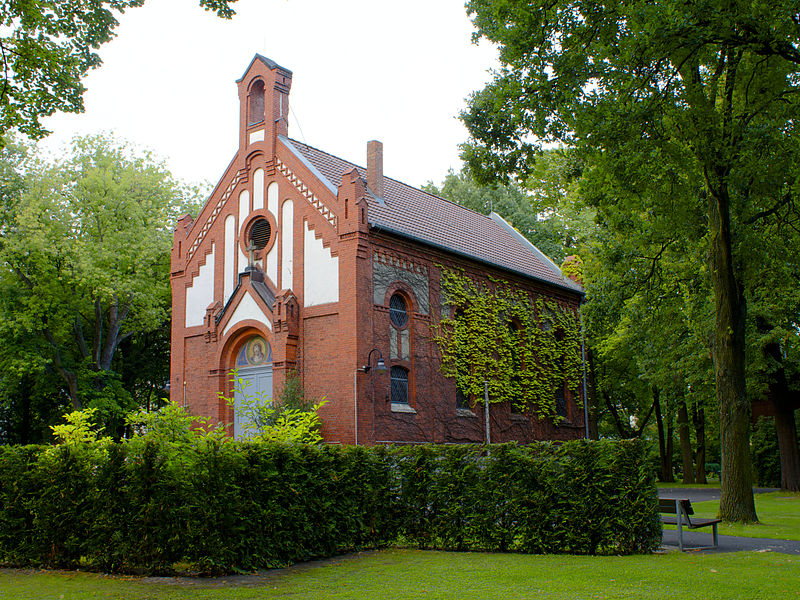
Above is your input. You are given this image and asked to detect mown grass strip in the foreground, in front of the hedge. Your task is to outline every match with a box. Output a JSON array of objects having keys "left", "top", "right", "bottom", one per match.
[{"left": 0, "top": 549, "right": 800, "bottom": 600}]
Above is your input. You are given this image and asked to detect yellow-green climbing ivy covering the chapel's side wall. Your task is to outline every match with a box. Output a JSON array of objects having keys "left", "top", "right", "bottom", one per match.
[{"left": 434, "top": 269, "right": 582, "bottom": 419}]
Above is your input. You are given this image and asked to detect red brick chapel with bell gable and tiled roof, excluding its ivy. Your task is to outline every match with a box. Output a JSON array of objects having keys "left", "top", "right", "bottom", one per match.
[{"left": 170, "top": 55, "right": 584, "bottom": 444}]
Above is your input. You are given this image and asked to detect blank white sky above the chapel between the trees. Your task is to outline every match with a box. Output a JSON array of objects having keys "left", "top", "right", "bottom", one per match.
[{"left": 40, "top": 0, "right": 496, "bottom": 186}]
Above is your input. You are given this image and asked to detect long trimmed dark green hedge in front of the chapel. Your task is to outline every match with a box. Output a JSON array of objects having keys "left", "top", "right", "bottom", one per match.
[{"left": 0, "top": 441, "right": 661, "bottom": 573}]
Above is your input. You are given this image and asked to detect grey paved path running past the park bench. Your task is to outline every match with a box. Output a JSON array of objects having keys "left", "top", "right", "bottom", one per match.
[{"left": 658, "top": 488, "right": 800, "bottom": 556}]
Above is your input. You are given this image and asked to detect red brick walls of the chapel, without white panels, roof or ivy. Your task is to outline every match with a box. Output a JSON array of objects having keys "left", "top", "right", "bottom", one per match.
[{"left": 170, "top": 57, "right": 583, "bottom": 444}]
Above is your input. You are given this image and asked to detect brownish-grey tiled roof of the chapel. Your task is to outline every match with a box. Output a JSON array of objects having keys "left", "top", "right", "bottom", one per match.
[{"left": 280, "top": 136, "right": 583, "bottom": 293}]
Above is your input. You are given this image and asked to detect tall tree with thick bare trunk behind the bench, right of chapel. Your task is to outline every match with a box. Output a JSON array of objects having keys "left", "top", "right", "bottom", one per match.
[{"left": 463, "top": 0, "right": 800, "bottom": 521}]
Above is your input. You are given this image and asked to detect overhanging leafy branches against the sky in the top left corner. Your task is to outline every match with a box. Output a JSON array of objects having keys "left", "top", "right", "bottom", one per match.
[{"left": 0, "top": 0, "right": 236, "bottom": 141}]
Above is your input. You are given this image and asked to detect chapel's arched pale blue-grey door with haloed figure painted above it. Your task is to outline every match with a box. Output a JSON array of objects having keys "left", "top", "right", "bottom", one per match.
[{"left": 233, "top": 335, "right": 272, "bottom": 439}]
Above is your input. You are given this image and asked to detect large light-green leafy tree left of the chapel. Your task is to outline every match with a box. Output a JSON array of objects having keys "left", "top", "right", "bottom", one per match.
[{"left": 0, "top": 137, "right": 198, "bottom": 430}]
